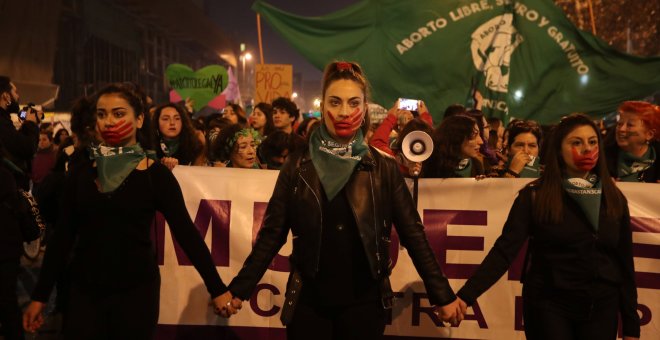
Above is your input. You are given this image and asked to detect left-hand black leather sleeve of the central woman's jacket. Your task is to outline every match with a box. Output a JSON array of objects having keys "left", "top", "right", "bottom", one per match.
[{"left": 229, "top": 156, "right": 297, "bottom": 300}]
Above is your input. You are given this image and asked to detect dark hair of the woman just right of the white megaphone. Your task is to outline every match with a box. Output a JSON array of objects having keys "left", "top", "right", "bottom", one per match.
[{"left": 422, "top": 114, "right": 483, "bottom": 178}]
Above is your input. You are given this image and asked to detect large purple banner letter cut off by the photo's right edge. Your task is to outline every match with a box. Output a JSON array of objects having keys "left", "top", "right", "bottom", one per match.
[{"left": 630, "top": 217, "right": 660, "bottom": 289}]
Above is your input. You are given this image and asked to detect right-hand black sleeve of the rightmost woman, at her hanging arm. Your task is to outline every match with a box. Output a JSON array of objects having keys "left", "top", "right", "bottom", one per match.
[{"left": 618, "top": 202, "right": 641, "bottom": 338}]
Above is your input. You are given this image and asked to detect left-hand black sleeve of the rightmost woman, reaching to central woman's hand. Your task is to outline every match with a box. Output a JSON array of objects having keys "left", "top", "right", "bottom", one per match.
[{"left": 456, "top": 187, "right": 535, "bottom": 305}]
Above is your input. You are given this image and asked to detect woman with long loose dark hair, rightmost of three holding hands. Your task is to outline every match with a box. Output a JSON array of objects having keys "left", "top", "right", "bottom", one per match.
[{"left": 457, "top": 114, "right": 640, "bottom": 340}]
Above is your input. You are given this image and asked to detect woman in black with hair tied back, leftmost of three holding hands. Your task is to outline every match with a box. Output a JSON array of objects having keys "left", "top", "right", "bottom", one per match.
[{"left": 23, "top": 83, "right": 231, "bottom": 339}]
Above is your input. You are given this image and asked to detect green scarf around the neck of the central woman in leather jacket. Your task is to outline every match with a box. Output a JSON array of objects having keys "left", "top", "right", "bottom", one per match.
[{"left": 309, "top": 124, "right": 369, "bottom": 201}]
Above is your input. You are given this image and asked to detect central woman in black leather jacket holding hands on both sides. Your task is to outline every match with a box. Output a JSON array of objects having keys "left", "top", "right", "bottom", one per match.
[{"left": 230, "top": 62, "right": 463, "bottom": 339}]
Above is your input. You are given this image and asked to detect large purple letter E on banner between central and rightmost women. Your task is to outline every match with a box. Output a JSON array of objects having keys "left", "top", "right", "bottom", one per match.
[{"left": 424, "top": 209, "right": 488, "bottom": 279}]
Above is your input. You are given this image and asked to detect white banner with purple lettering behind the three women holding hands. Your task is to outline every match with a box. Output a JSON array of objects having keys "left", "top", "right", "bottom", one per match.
[{"left": 156, "top": 166, "right": 660, "bottom": 339}]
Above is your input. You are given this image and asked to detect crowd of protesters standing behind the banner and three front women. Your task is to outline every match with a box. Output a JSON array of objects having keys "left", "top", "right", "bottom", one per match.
[{"left": 6, "top": 79, "right": 660, "bottom": 202}]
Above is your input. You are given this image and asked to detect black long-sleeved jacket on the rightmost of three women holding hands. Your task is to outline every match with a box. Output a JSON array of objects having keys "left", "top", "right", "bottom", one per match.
[{"left": 456, "top": 183, "right": 640, "bottom": 337}]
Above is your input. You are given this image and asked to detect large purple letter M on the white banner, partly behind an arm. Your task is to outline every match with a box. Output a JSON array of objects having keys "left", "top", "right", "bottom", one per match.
[{"left": 152, "top": 199, "right": 231, "bottom": 267}]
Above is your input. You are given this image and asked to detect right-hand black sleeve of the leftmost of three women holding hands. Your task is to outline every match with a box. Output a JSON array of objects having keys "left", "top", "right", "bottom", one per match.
[{"left": 153, "top": 164, "right": 227, "bottom": 298}]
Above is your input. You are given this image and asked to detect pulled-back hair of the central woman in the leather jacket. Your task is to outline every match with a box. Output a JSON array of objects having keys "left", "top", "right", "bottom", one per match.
[{"left": 321, "top": 61, "right": 371, "bottom": 136}]
